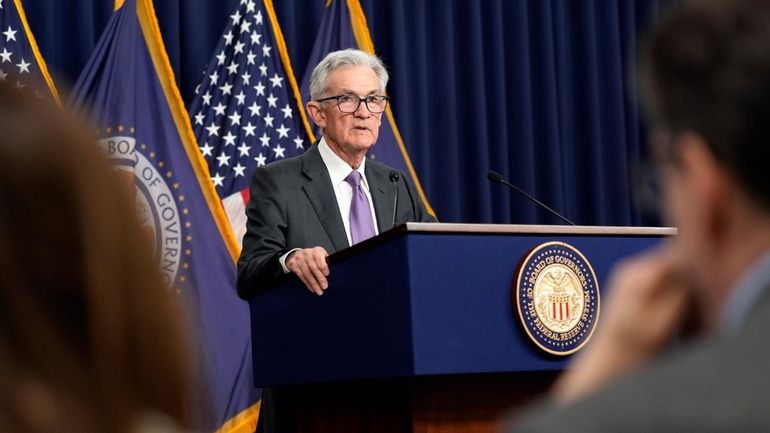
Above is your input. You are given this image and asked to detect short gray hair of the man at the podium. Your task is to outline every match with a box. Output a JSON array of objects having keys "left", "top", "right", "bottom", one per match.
[{"left": 310, "top": 48, "right": 388, "bottom": 101}]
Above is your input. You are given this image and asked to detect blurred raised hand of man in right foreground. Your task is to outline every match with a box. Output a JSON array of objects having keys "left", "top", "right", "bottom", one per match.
[{"left": 554, "top": 250, "right": 692, "bottom": 404}]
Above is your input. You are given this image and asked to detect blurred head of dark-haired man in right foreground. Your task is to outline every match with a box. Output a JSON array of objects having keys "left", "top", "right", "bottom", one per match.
[{"left": 641, "top": 0, "right": 770, "bottom": 296}]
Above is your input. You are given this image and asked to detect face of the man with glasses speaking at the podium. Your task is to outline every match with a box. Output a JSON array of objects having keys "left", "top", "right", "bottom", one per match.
[{"left": 309, "top": 65, "right": 382, "bottom": 154}]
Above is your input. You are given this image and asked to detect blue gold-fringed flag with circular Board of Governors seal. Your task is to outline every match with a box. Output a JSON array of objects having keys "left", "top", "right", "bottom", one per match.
[{"left": 72, "top": 0, "right": 259, "bottom": 432}]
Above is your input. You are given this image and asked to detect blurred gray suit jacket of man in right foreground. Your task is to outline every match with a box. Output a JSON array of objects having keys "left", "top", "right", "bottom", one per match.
[{"left": 506, "top": 288, "right": 770, "bottom": 433}]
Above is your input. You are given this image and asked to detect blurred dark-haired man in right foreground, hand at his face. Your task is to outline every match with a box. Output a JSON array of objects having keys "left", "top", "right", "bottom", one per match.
[{"left": 507, "top": 0, "right": 770, "bottom": 433}]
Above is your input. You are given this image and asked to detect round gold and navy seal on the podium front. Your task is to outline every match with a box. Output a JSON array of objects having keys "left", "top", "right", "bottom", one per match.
[{"left": 513, "top": 242, "right": 600, "bottom": 355}]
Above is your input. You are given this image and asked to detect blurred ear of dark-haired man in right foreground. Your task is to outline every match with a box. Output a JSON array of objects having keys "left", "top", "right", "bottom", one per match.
[{"left": 677, "top": 133, "right": 736, "bottom": 238}]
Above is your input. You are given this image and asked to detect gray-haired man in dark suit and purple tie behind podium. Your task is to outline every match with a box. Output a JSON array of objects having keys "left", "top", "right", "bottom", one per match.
[{"left": 238, "top": 49, "right": 433, "bottom": 298}]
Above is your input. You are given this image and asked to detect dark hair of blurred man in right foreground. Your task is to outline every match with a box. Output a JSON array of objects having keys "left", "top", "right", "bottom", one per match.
[{"left": 641, "top": 0, "right": 770, "bottom": 206}]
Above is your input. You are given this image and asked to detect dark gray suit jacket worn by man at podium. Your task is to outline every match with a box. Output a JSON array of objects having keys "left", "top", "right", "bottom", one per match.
[{"left": 237, "top": 145, "right": 434, "bottom": 299}]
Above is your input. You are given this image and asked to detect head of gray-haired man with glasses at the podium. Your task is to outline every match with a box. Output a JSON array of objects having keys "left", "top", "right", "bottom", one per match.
[{"left": 307, "top": 49, "right": 388, "bottom": 164}]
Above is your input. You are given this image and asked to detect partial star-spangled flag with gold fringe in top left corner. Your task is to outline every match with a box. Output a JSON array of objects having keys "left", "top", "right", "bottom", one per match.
[{"left": 0, "top": 0, "right": 60, "bottom": 103}]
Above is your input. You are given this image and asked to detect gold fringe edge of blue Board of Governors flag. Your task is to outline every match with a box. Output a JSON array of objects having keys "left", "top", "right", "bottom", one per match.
[{"left": 136, "top": 0, "right": 240, "bottom": 262}]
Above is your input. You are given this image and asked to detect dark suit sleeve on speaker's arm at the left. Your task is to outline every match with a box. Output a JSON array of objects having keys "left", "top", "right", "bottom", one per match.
[{"left": 237, "top": 167, "right": 288, "bottom": 299}]
